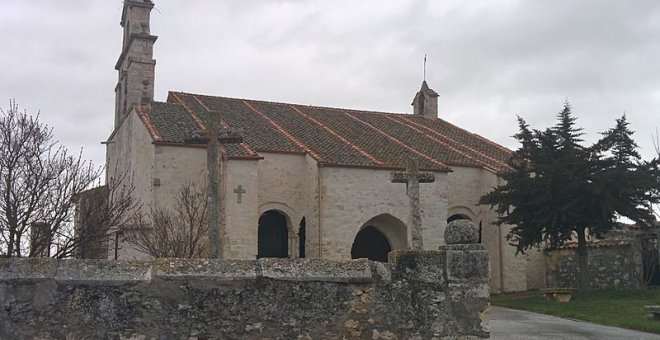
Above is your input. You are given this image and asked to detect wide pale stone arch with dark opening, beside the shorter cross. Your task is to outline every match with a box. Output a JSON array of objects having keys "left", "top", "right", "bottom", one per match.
[{"left": 351, "top": 214, "right": 408, "bottom": 262}]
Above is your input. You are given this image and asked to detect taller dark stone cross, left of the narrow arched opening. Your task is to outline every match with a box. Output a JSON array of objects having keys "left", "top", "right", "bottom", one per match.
[{"left": 186, "top": 111, "right": 243, "bottom": 259}]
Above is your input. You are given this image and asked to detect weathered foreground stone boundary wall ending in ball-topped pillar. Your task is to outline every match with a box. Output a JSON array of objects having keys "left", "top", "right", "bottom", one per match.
[{"left": 0, "top": 248, "right": 490, "bottom": 339}]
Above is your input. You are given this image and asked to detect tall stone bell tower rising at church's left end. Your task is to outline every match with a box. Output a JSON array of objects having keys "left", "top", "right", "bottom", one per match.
[{"left": 115, "top": 0, "right": 158, "bottom": 128}]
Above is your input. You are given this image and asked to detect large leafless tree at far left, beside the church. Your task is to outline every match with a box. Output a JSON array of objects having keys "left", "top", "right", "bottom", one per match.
[{"left": 0, "top": 101, "right": 113, "bottom": 257}]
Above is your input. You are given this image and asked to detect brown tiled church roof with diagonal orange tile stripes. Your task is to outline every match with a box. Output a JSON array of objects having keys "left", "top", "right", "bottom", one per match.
[{"left": 138, "top": 92, "right": 511, "bottom": 171}]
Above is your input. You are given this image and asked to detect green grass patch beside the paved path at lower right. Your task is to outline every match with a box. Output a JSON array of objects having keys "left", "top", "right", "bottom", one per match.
[{"left": 491, "top": 288, "right": 660, "bottom": 334}]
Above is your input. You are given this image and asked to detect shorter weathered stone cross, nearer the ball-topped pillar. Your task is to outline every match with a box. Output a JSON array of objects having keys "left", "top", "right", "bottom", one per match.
[{"left": 390, "top": 157, "right": 435, "bottom": 250}]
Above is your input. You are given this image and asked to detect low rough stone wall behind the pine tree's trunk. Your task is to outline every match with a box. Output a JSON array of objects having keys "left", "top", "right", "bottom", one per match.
[{"left": 545, "top": 242, "right": 642, "bottom": 289}]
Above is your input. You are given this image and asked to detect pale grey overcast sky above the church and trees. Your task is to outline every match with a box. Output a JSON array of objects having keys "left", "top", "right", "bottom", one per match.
[{"left": 0, "top": 0, "right": 660, "bottom": 170}]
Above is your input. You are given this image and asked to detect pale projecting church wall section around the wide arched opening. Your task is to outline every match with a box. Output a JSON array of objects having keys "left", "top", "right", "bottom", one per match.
[{"left": 321, "top": 167, "right": 447, "bottom": 260}]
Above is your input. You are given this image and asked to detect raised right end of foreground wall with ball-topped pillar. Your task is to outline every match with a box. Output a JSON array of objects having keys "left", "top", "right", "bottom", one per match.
[{"left": 389, "top": 220, "right": 491, "bottom": 339}]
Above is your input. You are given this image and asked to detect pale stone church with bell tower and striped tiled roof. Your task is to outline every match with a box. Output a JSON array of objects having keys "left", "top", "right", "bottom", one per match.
[{"left": 107, "top": 0, "right": 538, "bottom": 292}]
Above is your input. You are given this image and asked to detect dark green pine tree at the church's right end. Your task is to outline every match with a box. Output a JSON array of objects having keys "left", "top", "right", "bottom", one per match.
[{"left": 480, "top": 102, "right": 660, "bottom": 289}]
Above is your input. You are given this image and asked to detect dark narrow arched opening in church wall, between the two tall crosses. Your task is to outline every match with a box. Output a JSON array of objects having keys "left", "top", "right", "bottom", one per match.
[{"left": 257, "top": 210, "right": 289, "bottom": 258}]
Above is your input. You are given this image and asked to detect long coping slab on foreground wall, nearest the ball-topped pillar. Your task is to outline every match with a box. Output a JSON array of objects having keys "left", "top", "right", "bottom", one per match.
[{"left": 258, "top": 258, "right": 373, "bottom": 283}]
